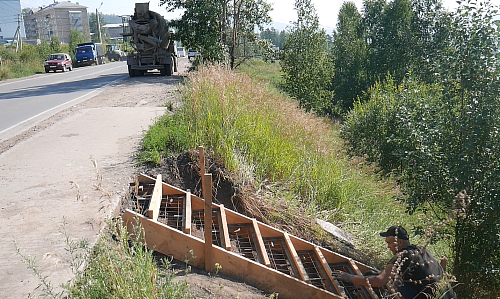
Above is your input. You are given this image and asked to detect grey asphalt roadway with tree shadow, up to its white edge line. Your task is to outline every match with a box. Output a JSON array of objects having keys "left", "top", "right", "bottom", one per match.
[{"left": 0, "top": 62, "right": 128, "bottom": 141}]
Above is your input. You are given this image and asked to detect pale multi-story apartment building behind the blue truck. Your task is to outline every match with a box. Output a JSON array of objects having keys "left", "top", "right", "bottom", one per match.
[{"left": 23, "top": 0, "right": 90, "bottom": 43}]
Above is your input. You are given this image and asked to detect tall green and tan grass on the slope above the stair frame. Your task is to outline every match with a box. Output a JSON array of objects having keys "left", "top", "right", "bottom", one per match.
[{"left": 141, "top": 62, "right": 450, "bottom": 268}]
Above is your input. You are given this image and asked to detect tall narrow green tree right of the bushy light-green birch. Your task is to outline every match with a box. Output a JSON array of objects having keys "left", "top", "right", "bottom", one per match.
[{"left": 332, "top": 2, "right": 370, "bottom": 115}]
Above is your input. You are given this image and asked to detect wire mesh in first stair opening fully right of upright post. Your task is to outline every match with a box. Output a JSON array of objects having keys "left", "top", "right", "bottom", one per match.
[{"left": 227, "top": 224, "right": 262, "bottom": 263}]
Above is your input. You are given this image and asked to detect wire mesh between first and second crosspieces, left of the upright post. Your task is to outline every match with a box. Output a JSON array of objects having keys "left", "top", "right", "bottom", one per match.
[{"left": 158, "top": 195, "right": 185, "bottom": 230}]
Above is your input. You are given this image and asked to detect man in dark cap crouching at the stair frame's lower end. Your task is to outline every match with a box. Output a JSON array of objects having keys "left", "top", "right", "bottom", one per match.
[{"left": 333, "top": 225, "right": 456, "bottom": 299}]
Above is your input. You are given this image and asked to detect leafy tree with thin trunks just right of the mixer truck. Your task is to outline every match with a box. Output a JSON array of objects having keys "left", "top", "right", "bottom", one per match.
[{"left": 160, "top": 0, "right": 271, "bottom": 68}]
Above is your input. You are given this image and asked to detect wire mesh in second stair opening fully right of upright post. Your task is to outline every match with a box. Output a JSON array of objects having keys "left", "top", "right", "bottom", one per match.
[{"left": 262, "top": 238, "right": 298, "bottom": 277}]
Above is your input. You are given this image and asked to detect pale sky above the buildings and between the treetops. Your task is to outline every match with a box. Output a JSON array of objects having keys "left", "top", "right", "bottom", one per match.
[{"left": 21, "top": 0, "right": 460, "bottom": 33}]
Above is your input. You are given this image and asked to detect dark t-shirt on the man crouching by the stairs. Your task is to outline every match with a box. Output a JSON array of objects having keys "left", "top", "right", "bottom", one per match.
[{"left": 389, "top": 245, "right": 455, "bottom": 299}]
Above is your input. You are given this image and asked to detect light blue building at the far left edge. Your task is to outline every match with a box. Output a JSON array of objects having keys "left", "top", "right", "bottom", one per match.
[{"left": 0, "top": 0, "right": 24, "bottom": 42}]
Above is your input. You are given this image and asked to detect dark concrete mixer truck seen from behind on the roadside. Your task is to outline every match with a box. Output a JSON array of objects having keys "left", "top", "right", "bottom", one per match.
[{"left": 123, "top": 3, "right": 177, "bottom": 77}]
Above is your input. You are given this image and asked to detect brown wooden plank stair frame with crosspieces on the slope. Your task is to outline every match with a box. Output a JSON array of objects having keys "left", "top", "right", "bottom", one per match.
[{"left": 123, "top": 175, "right": 394, "bottom": 299}]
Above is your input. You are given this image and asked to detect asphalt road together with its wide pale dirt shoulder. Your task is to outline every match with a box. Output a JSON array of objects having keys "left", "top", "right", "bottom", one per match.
[{"left": 0, "top": 59, "right": 189, "bottom": 299}]
